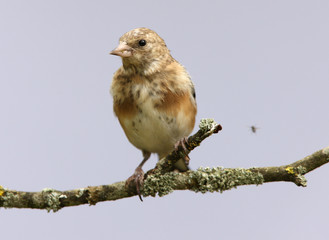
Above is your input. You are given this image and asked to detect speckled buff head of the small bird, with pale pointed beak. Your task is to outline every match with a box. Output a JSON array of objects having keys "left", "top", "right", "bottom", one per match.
[{"left": 110, "top": 28, "right": 173, "bottom": 75}]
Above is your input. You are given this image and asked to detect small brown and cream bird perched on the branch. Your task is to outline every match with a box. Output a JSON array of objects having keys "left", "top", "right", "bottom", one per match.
[{"left": 110, "top": 27, "right": 197, "bottom": 201}]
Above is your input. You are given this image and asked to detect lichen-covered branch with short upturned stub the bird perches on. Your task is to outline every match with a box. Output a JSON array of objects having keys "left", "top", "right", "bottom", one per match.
[{"left": 0, "top": 119, "right": 329, "bottom": 212}]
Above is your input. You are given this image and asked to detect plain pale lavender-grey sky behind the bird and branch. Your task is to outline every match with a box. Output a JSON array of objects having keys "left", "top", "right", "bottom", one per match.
[{"left": 0, "top": 0, "right": 329, "bottom": 239}]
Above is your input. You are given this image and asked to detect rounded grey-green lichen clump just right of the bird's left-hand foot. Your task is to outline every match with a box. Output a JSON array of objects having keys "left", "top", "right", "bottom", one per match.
[{"left": 143, "top": 172, "right": 178, "bottom": 197}]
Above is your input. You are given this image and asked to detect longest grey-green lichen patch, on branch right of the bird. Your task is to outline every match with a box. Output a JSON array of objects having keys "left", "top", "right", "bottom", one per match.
[{"left": 189, "top": 167, "right": 264, "bottom": 193}]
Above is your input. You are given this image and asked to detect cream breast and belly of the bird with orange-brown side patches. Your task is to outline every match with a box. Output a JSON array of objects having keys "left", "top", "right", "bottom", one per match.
[{"left": 111, "top": 65, "right": 196, "bottom": 155}]
